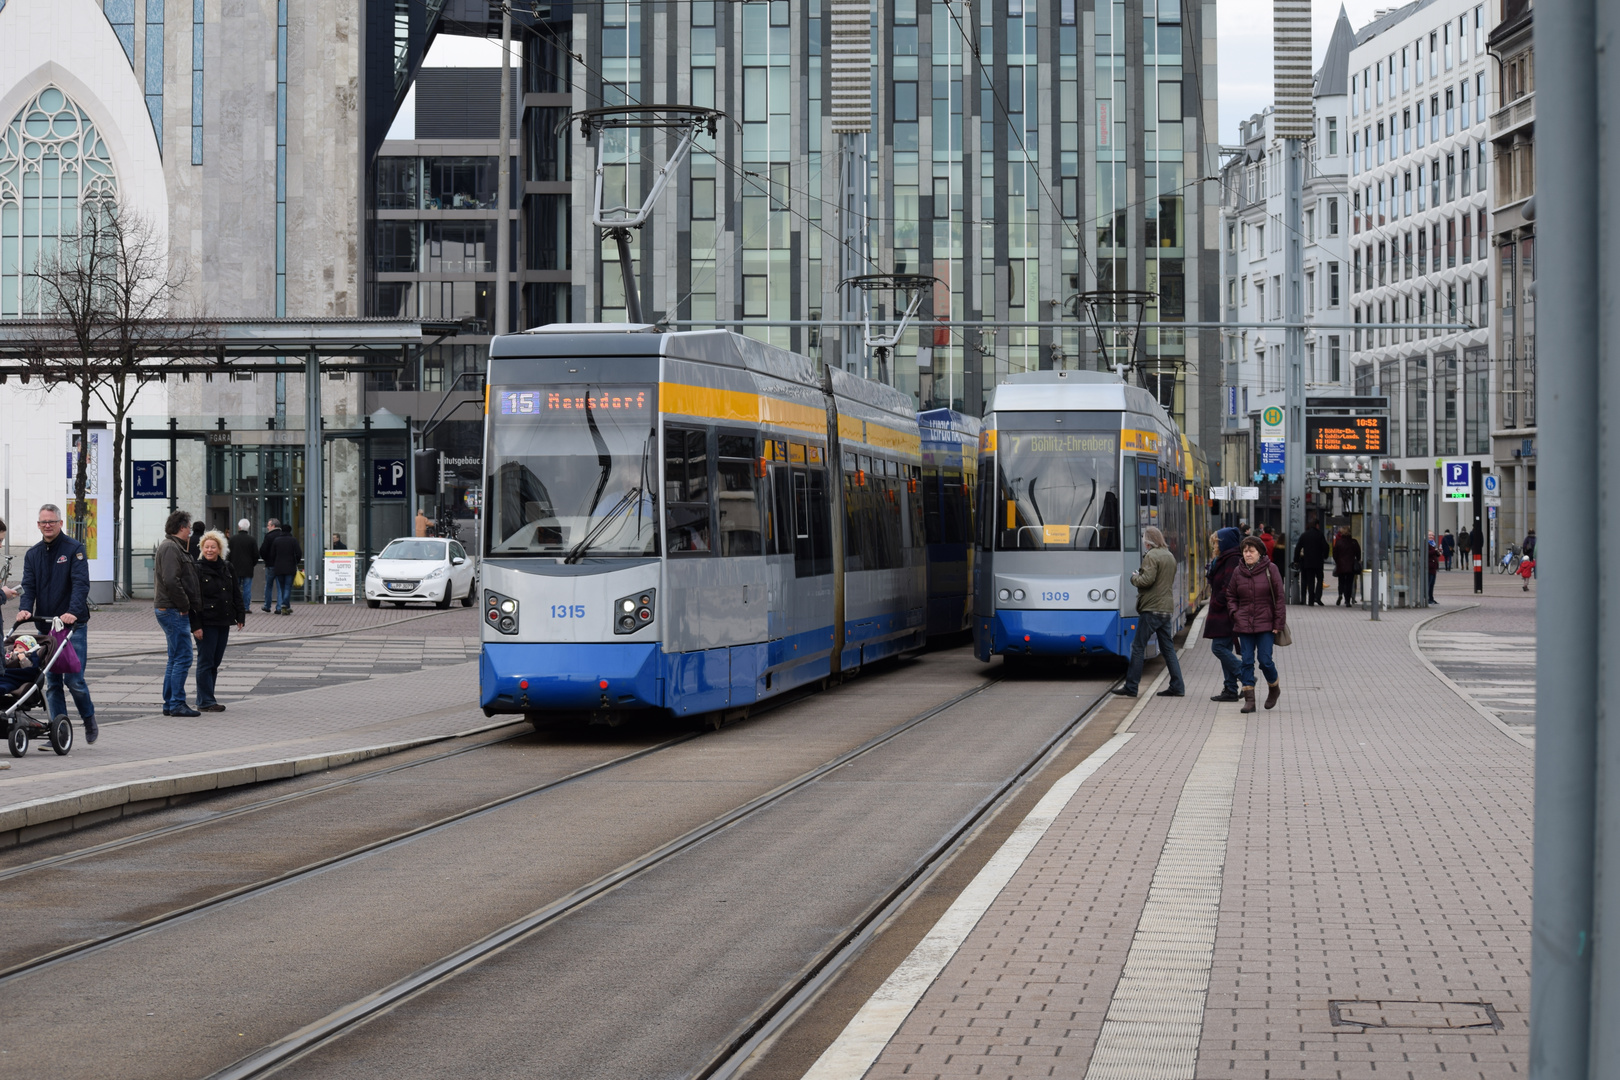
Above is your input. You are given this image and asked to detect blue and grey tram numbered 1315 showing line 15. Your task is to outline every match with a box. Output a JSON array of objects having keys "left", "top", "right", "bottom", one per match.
[{"left": 480, "top": 324, "right": 927, "bottom": 724}]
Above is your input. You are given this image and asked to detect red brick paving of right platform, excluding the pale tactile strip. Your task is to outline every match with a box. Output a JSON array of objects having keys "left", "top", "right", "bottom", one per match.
[{"left": 867, "top": 595, "right": 1533, "bottom": 1080}]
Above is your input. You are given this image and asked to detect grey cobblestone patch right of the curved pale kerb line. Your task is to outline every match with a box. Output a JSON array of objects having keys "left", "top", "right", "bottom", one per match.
[{"left": 1418, "top": 573, "right": 1536, "bottom": 738}]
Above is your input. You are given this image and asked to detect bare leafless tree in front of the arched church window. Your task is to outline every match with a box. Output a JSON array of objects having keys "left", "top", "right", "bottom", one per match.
[{"left": 15, "top": 210, "right": 217, "bottom": 592}]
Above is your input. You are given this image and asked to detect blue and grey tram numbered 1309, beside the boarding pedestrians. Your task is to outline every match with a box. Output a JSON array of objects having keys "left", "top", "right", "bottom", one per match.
[{"left": 974, "top": 371, "right": 1207, "bottom": 661}]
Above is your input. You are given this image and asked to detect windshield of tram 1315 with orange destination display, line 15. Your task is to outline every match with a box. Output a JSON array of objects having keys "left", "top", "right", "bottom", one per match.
[{"left": 484, "top": 385, "right": 658, "bottom": 562}]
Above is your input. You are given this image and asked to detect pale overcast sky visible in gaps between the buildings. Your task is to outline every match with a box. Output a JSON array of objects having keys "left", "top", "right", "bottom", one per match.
[{"left": 389, "top": 0, "right": 1400, "bottom": 146}]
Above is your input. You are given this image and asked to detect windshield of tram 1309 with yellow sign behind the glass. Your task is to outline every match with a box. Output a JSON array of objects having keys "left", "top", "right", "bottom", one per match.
[{"left": 995, "top": 427, "right": 1119, "bottom": 551}]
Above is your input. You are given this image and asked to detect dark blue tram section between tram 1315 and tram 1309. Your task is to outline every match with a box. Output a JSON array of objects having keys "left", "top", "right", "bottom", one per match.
[{"left": 917, "top": 408, "right": 980, "bottom": 638}]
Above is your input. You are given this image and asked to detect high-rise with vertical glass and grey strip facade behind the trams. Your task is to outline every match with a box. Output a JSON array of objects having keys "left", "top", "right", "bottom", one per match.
[{"left": 572, "top": 0, "right": 1220, "bottom": 459}]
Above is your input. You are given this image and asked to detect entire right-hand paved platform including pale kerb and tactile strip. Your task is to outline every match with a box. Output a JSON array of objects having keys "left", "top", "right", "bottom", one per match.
[{"left": 808, "top": 573, "right": 1533, "bottom": 1080}]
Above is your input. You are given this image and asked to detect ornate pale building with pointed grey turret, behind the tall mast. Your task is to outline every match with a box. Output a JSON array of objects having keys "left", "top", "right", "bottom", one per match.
[{"left": 1221, "top": 10, "right": 1354, "bottom": 508}]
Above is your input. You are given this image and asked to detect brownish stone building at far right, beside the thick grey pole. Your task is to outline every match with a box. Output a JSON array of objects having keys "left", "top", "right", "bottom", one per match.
[{"left": 1487, "top": 0, "right": 1536, "bottom": 544}]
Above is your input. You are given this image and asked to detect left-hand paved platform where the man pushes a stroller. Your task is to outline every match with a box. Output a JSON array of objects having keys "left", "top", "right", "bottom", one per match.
[{"left": 0, "top": 604, "right": 492, "bottom": 845}]
